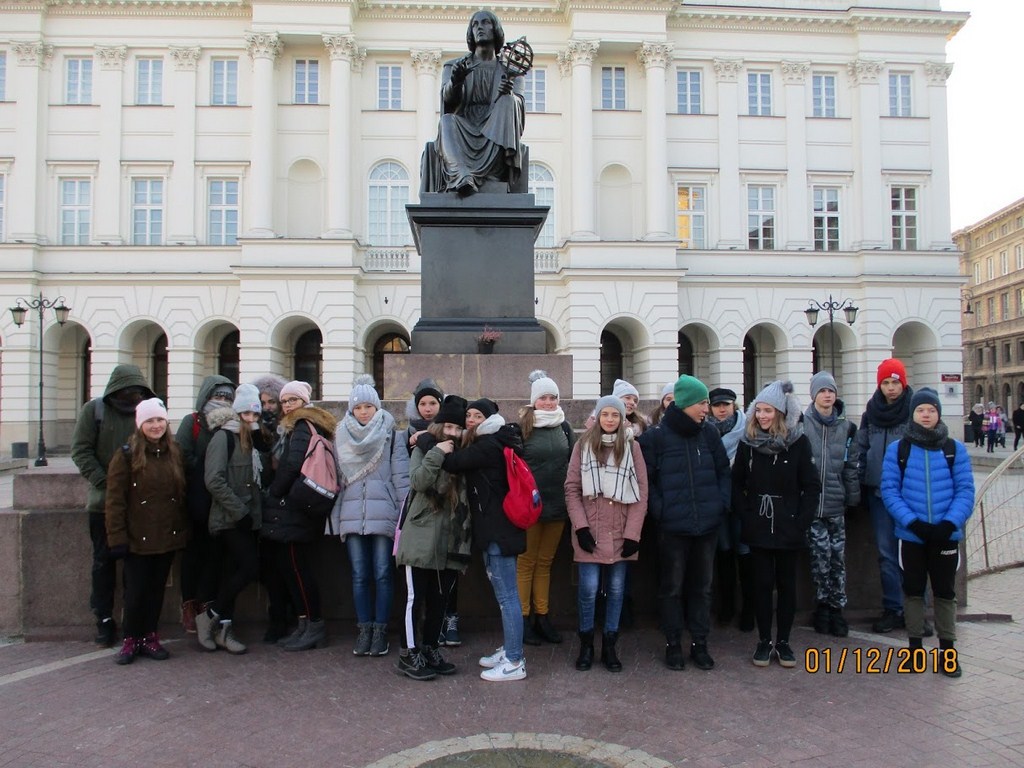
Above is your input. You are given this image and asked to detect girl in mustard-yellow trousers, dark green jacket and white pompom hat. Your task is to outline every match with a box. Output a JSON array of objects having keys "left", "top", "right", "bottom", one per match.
[{"left": 516, "top": 371, "right": 575, "bottom": 645}]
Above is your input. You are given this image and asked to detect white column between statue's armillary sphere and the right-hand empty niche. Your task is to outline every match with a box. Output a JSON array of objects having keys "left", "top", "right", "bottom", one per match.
[{"left": 558, "top": 40, "right": 600, "bottom": 241}]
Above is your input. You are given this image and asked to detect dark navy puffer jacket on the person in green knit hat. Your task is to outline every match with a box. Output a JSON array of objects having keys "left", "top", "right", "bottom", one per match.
[{"left": 639, "top": 403, "right": 731, "bottom": 536}]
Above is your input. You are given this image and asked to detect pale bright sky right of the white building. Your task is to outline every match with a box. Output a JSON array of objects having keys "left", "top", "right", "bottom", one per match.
[{"left": 942, "top": 0, "right": 1024, "bottom": 230}]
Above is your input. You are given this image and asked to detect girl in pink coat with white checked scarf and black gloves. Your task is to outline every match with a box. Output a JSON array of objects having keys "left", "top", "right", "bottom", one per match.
[{"left": 565, "top": 395, "right": 647, "bottom": 672}]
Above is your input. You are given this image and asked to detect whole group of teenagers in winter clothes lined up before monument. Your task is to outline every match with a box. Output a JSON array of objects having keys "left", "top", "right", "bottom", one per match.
[{"left": 72, "top": 358, "right": 974, "bottom": 681}]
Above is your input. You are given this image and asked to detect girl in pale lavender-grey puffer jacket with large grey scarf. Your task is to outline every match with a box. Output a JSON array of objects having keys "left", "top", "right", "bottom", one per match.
[{"left": 331, "top": 375, "right": 409, "bottom": 656}]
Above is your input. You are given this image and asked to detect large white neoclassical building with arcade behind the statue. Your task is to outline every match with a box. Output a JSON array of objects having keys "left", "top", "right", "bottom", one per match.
[{"left": 0, "top": 0, "right": 967, "bottom": 451}]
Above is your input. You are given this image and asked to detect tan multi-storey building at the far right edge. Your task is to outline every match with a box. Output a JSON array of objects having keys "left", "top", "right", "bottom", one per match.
[{"left": 953, "top": 199, "right": 1024, "bottom": 414}]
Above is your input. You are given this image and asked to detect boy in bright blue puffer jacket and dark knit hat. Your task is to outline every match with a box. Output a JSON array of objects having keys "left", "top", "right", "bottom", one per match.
[{"left": 881, "top": 387, "right": 974, "bottom": 677}]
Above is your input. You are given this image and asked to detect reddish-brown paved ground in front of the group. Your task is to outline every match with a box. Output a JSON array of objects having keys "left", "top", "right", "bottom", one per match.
[{"left": 0, "top": 568, "right": 1024, "bottom": 768}]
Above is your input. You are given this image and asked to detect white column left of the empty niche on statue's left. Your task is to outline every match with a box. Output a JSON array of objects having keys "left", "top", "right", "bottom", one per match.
[{"left": 246, "top": 32, "right": 282, "bottom": 238}]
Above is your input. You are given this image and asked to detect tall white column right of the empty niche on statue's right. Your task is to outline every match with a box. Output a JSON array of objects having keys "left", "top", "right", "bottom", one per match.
[{"left": 637, "top": 43, "right": 673, "bottom": 240}]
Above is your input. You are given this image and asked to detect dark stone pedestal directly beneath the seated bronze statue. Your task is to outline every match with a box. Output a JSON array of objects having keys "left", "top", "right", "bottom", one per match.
[{"left": 406, "top": 193, "right": 548, "bottom": 355}]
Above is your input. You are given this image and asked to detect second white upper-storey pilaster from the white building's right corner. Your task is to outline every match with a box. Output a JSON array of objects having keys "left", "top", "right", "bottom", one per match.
[{"left": 847, "top": 58, "right": 892, "bottom": 250}]
